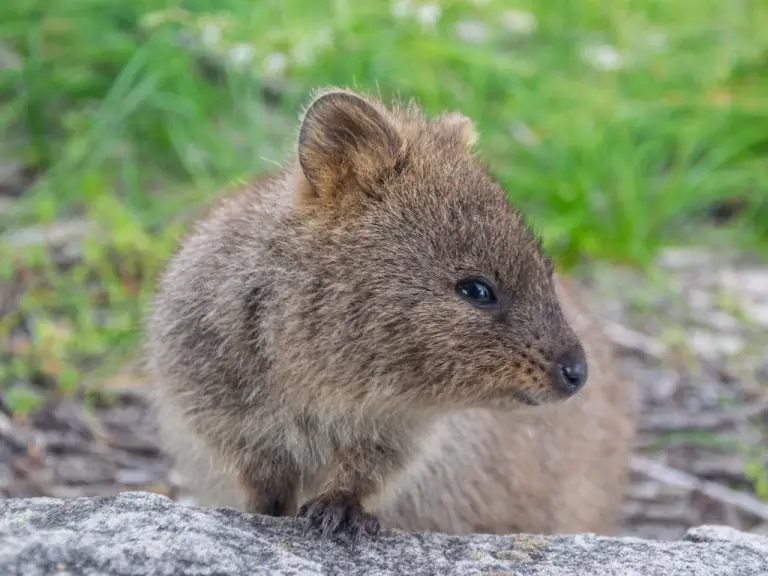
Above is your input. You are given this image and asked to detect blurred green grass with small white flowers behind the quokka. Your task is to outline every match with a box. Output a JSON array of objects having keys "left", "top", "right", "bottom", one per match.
[{"left": 0, "top": 0, "right": 768, "bottom": 407}]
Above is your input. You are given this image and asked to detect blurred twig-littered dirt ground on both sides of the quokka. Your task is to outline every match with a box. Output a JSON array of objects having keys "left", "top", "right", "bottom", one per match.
[{"left": 0, "top": 235, "right": 768, "bottom": 539}]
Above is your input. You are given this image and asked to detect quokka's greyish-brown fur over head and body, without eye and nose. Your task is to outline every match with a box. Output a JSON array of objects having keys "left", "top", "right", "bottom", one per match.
[{"left": 146, "top": 85, "right": 632, "bottom": 537}]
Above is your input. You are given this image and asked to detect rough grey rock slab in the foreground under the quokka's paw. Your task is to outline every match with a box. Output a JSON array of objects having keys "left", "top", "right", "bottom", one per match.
[{"left": 0, "top": 492, "right": 768, "bottom": 576}]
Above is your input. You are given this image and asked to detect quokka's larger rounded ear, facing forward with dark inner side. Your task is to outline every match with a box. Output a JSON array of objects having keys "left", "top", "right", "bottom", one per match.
[{"left": 298, "top": 89, "right": 402, "bottom": 197}]
